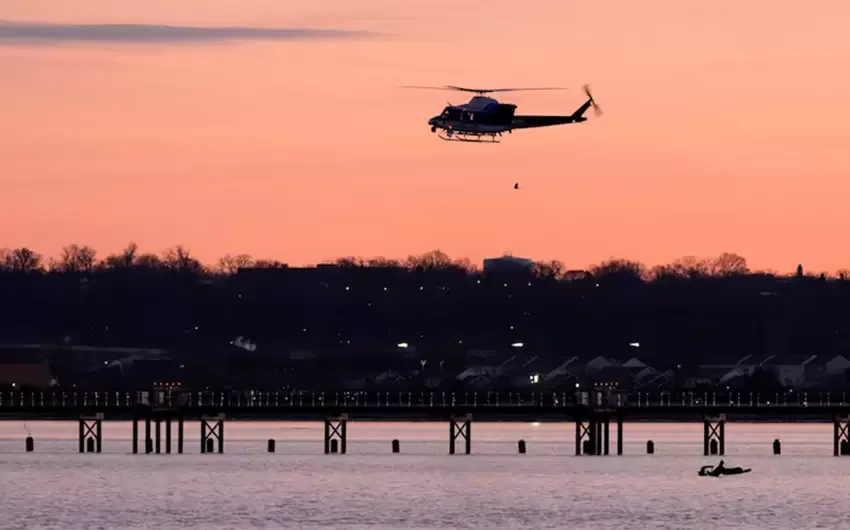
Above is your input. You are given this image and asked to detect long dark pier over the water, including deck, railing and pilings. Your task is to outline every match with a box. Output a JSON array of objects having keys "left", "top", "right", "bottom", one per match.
[{"left": 0, "top": 389, "right": 850, "bottom": 456}]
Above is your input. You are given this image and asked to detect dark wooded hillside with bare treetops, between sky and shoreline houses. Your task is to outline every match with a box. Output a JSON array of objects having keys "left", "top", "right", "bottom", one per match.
[{"left": 0, "top": 239, "right": 850, "bottom": 384}]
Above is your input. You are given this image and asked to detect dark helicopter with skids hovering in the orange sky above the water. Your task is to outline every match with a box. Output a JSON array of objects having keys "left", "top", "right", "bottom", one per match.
[{"left": 402, "top": 85, "right": 602, "bottom": 143}]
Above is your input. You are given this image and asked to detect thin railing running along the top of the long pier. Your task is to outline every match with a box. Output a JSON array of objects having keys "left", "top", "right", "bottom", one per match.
[{"left": 0, "top": 390, "right": 850, "bottom": 411}]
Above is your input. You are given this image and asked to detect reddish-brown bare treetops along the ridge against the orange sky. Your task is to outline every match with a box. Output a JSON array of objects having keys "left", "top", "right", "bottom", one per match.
[{"left": 0, "top": 242, "right": 850, "bottom": 281}]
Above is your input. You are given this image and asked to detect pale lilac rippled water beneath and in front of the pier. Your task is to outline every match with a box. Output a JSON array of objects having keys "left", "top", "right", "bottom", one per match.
[{"left": 0, "top": 422, "right": 850, "bottom": 530}]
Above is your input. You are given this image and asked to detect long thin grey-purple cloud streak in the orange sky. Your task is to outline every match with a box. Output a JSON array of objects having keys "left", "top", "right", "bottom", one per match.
[{"left": 0, "top": 21, "right": 374, "bottom": 45}]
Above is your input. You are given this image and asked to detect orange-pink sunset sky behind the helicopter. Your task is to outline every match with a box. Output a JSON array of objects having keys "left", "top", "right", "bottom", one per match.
[{"left": 0, "top": 0, "right": 850, "bottom": 271}]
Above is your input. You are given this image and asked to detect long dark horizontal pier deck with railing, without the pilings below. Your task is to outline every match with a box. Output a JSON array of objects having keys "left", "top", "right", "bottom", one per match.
[{"left": 0, "top": 390, "right": 850, "bottom": 421}]
